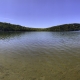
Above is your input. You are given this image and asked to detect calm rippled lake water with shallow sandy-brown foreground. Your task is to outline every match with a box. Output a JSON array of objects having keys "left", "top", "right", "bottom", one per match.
[{"left": 0, "top": 31, "right": 80, "bottom": 80}]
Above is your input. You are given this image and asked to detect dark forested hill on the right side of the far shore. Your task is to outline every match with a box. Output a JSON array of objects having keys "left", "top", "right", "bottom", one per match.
[{"left": 47, "top": 23, "right": 80, "bottom": 31}]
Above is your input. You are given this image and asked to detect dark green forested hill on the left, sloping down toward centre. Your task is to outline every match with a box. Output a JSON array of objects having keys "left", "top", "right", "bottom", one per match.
[{"left": 0, "top": 22, "right": 42, "bottom": 31}]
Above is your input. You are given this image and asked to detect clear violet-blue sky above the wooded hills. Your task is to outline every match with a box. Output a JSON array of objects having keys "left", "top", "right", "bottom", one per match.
[{"left": 0, "top": 0, "right": 80, "bottom": 28}]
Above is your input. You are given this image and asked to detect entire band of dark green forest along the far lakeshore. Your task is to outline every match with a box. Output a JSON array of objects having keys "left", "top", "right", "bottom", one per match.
[{"left": 0, "top": 22, "right": 80, "bottom": 31}]
